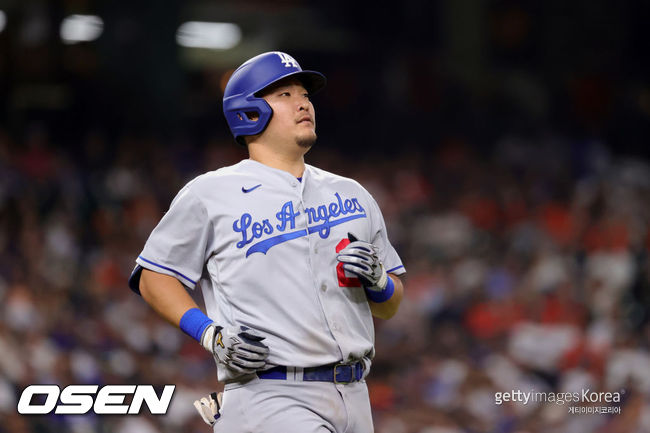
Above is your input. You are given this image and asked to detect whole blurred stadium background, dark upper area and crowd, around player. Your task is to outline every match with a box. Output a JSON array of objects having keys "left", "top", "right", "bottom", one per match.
[{"left": 0, "top": 0, "right": 650, "bottom": 433}]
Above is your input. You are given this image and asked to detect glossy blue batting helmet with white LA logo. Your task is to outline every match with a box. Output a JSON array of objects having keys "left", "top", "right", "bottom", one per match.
[{"left": 223, "top": 51, "right": 325, "bottom": 144}]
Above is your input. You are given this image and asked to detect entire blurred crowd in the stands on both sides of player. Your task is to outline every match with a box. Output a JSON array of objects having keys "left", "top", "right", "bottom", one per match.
[{"left": 0, "top": 124, "right": 650, "bottom": 433}]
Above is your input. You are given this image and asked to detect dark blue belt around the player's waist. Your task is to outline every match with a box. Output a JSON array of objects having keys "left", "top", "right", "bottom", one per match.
[{"left": 257, "top": 361, "right": 363, "bottom": 384}]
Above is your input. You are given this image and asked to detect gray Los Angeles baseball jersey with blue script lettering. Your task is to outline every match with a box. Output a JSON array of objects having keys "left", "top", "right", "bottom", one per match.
[{"left": 136, "top": 159, "right": 405, "bottom": 380}]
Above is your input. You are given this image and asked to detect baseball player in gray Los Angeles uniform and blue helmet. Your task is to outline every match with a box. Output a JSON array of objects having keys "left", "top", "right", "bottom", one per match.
[{"left": 129, "top": 52, "right": 405, "bottom": 433}]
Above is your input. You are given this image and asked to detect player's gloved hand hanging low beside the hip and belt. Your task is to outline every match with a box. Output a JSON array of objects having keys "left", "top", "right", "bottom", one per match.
[{"left": 201, "top": 323, "right": 269, "bottom": 374}]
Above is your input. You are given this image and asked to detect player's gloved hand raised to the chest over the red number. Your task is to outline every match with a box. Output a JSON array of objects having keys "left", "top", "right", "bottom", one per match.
[{"left": 336, "top": 233, "right": 388, "bottom": 292}]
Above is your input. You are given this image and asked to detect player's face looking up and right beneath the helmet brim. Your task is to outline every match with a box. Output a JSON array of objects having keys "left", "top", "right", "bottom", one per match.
[{"left": 262, "top": 79, "right": 316, "bottom": 149}]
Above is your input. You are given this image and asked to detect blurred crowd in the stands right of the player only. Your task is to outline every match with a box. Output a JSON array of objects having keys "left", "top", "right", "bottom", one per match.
[{"left": 368, "top": 137, "right": 650, "bottom": 433}]
